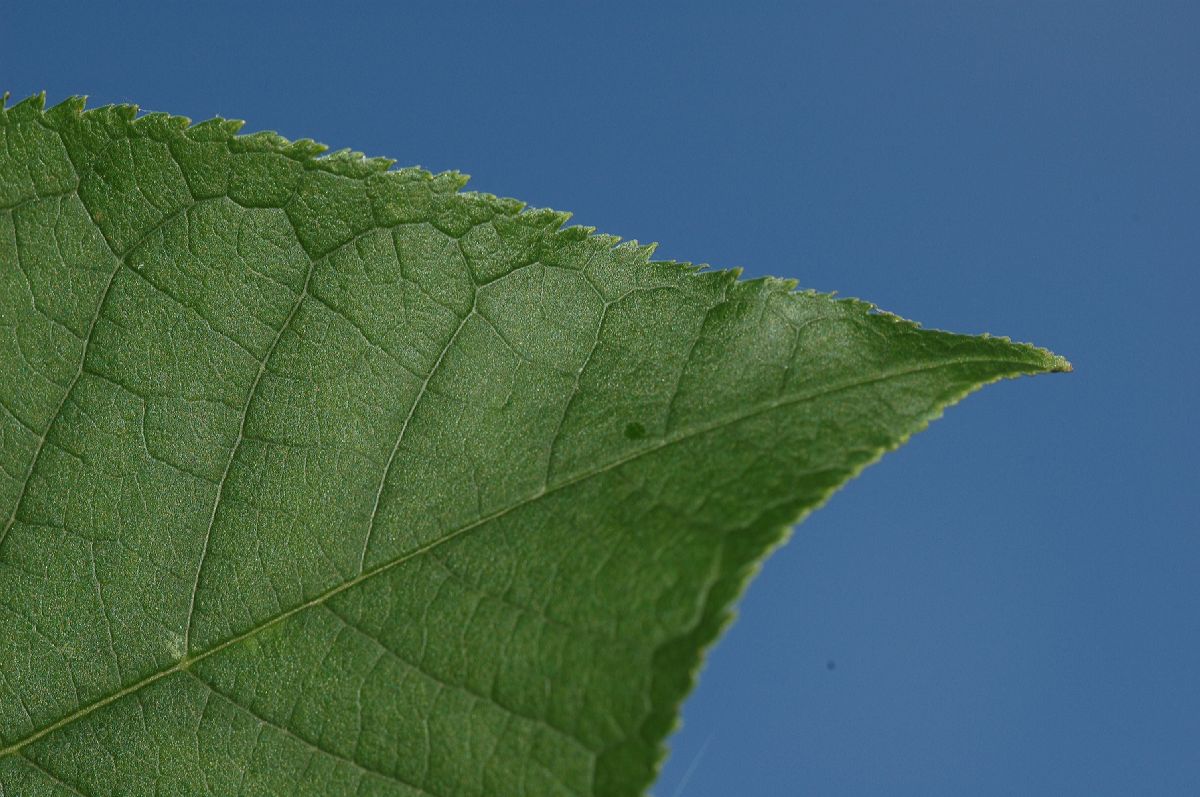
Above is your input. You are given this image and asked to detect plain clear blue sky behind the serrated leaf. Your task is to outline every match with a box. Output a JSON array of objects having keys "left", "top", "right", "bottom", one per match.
[{"left": 0, "top": 0, "right": 1200, "bottom": 797}]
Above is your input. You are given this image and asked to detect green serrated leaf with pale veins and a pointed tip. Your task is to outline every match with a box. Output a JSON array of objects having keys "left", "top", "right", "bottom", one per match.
[{"left": 0, "top": 97, "right": 1069, "bottom": 796}]
